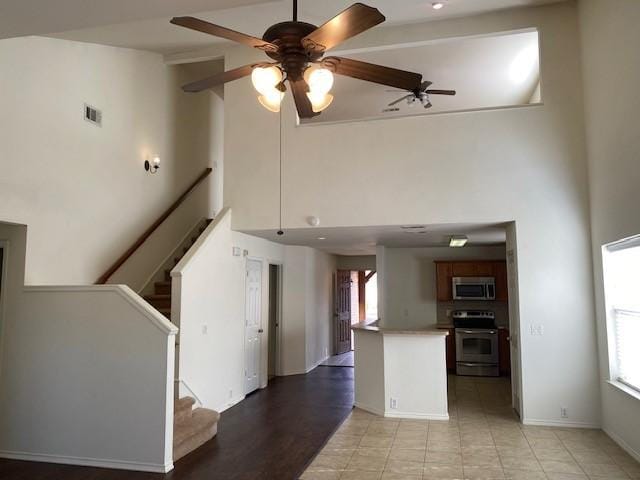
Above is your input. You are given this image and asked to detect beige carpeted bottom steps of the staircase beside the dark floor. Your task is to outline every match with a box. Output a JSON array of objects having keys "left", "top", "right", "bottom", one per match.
[{"left": 173, "top": 397, "right": 220, "bottom": 462}]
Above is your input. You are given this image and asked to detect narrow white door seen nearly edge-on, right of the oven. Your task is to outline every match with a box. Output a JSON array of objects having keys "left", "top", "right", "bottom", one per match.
[{"left": 507, "top": 249, "right": 522, "bottom": 418}]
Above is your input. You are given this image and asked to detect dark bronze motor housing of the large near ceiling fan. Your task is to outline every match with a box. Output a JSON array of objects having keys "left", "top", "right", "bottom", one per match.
[{"left": 262, "top": 22, "right": 323, "bottom": 81}]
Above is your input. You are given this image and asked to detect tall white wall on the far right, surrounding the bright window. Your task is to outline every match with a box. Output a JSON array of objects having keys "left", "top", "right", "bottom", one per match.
[{"left": 580, "top": 0, "right": 640, "bottom": 459}]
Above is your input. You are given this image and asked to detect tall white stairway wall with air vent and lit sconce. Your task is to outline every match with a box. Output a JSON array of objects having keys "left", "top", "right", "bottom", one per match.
[{"left": 0, "top": 37, "right": 215, "bottom": 285}]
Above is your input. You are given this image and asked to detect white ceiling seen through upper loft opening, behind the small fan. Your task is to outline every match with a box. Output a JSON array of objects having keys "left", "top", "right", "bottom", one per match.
[{"left": 303, "top": 31, "right": 540, "bottom": 123}]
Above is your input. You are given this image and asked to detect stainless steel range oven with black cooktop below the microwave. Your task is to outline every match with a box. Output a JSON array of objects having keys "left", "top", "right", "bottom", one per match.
[{"left": 453, "top": 311, "right": 500, "bottom": 377}]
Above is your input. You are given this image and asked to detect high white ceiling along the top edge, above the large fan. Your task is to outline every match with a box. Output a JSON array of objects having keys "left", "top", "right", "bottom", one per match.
[{"left": 46, "top": 0, "right": 561, "bottom": 54}]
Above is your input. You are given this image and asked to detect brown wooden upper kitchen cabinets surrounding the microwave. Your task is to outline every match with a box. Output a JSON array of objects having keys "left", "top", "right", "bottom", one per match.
[{"left": 435, "top": 260, "right": 509, "bottom": 302}]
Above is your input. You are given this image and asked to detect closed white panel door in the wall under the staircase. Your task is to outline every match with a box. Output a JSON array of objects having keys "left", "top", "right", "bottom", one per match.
[{"left": 244, "top": 260, "right": 262, "bottom": 394}]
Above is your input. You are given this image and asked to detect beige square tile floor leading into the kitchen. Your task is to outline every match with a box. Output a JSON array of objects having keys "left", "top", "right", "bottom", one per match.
[{"left": 301, "top": 376, "right": 640, "bottom": 480}]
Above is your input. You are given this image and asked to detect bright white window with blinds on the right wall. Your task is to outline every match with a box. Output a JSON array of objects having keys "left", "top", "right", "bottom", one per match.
[{"left": 603, "top": 236, "right": 640, "bottom": 391}]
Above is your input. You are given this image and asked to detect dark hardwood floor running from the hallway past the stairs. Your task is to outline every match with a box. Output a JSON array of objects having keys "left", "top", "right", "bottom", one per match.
[{"left": 0, "top": 367, "right": 353, "bottom": 480}]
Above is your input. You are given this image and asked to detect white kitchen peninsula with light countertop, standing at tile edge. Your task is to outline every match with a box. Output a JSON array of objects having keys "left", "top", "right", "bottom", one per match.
[{"left": 352, "top": 322, "right": 449, "bottom": 420}]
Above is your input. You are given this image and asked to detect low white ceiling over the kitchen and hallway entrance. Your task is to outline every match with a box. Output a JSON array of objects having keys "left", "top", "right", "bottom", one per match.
[{"left": 245, "top": 224, "right": 506, "bottom": 255}]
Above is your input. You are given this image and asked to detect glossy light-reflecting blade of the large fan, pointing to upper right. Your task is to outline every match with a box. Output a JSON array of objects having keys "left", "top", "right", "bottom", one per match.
[{"left": 302, "top": 3, "right": 386, "bottom": 52}]
